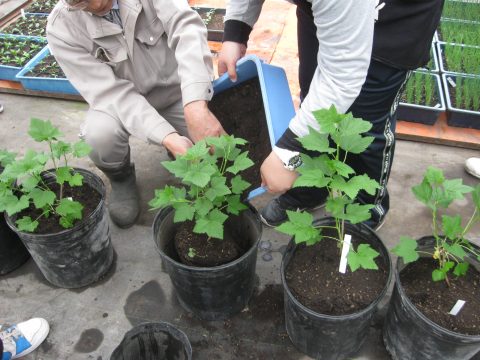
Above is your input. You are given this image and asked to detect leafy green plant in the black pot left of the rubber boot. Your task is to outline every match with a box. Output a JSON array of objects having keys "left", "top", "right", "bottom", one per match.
[{"left": 0, "top": 118, "right": 91, "bottom": 232}]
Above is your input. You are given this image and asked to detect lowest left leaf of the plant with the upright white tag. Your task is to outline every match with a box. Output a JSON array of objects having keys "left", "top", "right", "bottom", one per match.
[{"left": 276, "top": 210, "right": 320, "bottom": 245}]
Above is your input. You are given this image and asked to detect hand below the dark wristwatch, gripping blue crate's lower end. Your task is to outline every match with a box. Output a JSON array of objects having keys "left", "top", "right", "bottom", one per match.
[{"left": 260, "top": 151, "right": 298, "bottom": 194}]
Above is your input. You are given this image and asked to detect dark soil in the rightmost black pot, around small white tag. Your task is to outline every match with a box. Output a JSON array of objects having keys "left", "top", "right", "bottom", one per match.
[{"left": 400, "top": 258, "right": 480, "bottom": 335}]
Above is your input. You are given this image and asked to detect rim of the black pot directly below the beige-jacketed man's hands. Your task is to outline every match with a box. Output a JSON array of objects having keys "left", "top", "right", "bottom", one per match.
[{"left": 152, "top": 206, "right": 263, "bottom": 272}]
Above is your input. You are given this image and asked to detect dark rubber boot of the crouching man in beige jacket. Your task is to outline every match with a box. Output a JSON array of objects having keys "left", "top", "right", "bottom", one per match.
[{"left": 100, "top": 161, "right": 140, "bottom": 228}]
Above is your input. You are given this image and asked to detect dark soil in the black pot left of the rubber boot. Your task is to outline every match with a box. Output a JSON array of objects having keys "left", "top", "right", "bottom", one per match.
[{"left": 17, "top": 183, "right": 102, "bottom": 234}]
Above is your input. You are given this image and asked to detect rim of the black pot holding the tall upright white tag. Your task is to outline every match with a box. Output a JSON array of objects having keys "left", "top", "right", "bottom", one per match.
[{"left": 280, "top": 217, "right": 393, "bottom": 320}]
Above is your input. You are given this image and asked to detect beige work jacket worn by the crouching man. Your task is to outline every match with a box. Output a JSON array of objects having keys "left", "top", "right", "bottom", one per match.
[{"left": 47, "top": 0, "right": 214, "bottom": 144}]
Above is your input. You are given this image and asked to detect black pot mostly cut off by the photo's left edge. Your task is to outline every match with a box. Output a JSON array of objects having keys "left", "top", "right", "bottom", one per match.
[{"left": 0, "top": 213, "right": 30, "bottom": 275}]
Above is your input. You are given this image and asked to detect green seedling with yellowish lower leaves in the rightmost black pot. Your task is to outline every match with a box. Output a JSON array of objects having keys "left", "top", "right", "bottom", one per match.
[{"left": 392, "top": 166, "right": 480, "bottom": 286}]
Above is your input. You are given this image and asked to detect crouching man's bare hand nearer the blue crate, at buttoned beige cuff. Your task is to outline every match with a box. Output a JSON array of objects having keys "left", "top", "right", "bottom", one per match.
[{"left": 184, "top": 101, "right": 226, "bottom": 143}]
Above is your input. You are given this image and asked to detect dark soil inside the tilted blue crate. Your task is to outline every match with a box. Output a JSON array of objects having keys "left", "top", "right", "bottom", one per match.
[{"left": 208, "top": 77, "right": 272, "bottom": 193}]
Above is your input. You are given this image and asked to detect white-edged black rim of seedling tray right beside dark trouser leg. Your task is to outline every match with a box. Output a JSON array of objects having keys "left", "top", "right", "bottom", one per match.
[{"left": 397, "top": 73, "right": 446, "bottom": 125}]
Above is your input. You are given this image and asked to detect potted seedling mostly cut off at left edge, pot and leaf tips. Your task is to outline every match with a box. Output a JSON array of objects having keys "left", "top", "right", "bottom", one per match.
[{"left": 0, "top": 150, "right": 30, "bottom": 275}]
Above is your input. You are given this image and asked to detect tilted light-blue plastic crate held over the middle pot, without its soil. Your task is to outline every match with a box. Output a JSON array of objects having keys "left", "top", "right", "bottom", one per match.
[{"left": 213, "top": 55, "right": 295, "bottom": 200}]
